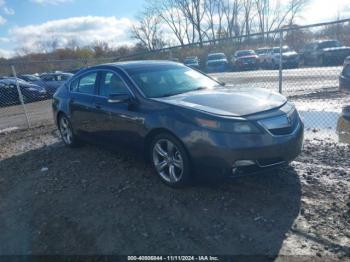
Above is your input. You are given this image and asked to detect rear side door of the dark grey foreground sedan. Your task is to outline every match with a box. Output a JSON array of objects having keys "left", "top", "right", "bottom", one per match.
[{"left": 69, "top": 71, "right": 98, "bottom": 138}]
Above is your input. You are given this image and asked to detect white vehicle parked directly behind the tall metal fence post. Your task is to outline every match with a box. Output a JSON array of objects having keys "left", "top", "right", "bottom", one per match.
[{"left": 267, "top": 46, "right": 299, "bottom": 69}]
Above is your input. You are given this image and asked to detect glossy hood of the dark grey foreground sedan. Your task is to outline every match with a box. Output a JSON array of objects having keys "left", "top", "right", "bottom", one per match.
[{"left": 154, "top": 87, "right": 287, "bottom": 117}]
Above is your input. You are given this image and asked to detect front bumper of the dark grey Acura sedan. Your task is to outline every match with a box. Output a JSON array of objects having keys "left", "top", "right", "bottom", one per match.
[{"left": 189, "top": 120, "right": 304, "bottom": 176}]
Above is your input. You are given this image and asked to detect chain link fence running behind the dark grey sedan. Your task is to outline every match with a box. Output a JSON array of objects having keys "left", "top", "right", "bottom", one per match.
[{"left": 0, "top": 19, "right": 350, "bottom": 143}]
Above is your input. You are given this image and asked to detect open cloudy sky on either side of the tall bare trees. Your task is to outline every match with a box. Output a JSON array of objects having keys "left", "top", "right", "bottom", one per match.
[{"left": 0, "top": 0, "right": 350, "bottom": 57}]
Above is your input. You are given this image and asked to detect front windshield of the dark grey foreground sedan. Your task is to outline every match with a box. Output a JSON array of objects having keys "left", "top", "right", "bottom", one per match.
[{"left": 128, "top": 66, "right": 219, "bottom": 98}]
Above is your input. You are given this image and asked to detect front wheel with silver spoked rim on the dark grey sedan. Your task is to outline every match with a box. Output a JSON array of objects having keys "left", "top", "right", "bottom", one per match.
[{"left": 149, "top": 133, "right": 191, "bottom": 188}]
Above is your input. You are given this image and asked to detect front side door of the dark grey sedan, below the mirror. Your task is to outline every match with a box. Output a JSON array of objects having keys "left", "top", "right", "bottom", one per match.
[{"left": 94, "top": 71, "right": 144, "bottom": 146}]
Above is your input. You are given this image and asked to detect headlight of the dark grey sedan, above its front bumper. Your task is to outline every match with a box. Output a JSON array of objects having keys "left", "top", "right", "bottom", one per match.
[{"left": 196, "top": 118, "right": 260, "bottom": 134}]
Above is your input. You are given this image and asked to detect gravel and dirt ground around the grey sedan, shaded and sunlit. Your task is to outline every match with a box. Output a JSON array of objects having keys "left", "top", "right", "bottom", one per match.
[{"left": 0, "top": 126, "right": 350, "bottom": 261}]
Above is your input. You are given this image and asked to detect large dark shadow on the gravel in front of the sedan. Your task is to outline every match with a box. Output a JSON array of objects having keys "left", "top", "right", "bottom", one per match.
[{"left": 0, "top": 143, "right": 301, "bottom": 256}]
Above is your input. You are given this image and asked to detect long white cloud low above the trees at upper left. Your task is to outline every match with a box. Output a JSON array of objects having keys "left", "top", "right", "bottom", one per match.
[{"left": 9, "top": 16, "right": 132, "bottom": 52}]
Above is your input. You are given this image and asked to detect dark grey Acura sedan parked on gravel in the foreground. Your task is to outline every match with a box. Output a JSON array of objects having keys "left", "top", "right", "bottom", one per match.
[{"left": 53, "top": 61, "right": 303, "bottom": 187}]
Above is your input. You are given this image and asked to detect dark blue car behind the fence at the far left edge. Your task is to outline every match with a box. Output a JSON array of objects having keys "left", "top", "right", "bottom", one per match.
[{"left": 0, "top": 77, "right": 48, "bottom": 106}]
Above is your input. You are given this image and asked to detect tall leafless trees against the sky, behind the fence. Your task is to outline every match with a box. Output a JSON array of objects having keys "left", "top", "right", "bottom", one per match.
[{"left": 132, "top": 0, "right": 309, "bottom": 50}]
